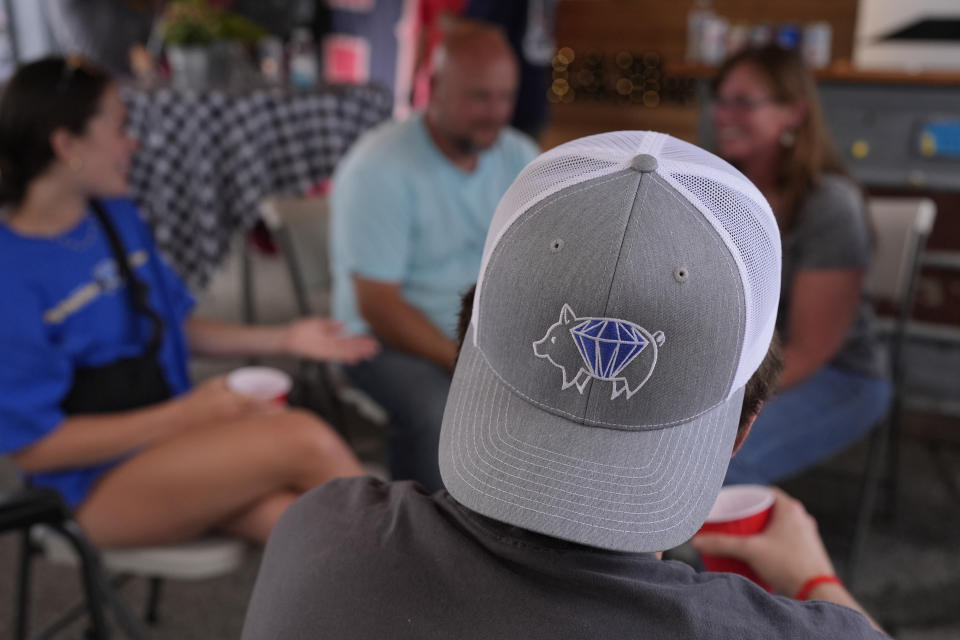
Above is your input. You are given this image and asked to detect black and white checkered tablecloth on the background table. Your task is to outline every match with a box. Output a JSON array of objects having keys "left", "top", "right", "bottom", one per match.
[{"left": 123, "top": 85, "right": 392, "bottom": 288}]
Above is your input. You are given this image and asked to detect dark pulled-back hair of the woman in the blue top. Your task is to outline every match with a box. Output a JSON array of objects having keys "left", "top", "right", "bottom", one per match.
[{"left": 0, "top": 57, "right": 111, "bottom": 206}]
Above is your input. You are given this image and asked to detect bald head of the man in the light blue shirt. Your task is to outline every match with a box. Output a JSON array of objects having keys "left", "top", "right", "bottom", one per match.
[{"left": 427, "top": 20, "right": 519, "bottom": 154}]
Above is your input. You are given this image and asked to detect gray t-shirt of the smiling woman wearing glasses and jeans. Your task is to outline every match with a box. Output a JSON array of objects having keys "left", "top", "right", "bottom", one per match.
[{"left": 777, "top": 174, "right": 887, "bottom": 378}]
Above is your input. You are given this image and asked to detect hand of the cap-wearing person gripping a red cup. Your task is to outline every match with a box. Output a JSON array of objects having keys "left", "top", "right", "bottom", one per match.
[{"left": 692, "top": 488, "right": 834, "bottom": 596}]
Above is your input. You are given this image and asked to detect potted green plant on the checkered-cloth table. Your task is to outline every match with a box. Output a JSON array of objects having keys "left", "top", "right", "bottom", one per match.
[{"left": 162, "top": 0, "right": 266, "bottom": 89}]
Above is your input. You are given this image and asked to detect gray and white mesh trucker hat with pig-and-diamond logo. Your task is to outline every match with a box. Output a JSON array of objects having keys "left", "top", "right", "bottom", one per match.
[{"left": 440, "top": 131, "right": 780, "bottom": 551}]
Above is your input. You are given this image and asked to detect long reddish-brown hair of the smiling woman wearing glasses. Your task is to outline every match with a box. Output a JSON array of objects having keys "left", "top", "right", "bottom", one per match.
[{"left": 712, "top": 46, "right": 853, "bottom": 231}]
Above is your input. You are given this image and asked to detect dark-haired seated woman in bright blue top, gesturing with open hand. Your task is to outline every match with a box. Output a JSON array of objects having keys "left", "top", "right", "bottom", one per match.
[{"left": 0, "top": 58, "right": 377, "bottom": 547}]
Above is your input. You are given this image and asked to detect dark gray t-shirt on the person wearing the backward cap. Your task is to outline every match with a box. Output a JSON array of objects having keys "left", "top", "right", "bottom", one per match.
[{"left": 242, "top": 478, "right": 885, "bottom": 640}]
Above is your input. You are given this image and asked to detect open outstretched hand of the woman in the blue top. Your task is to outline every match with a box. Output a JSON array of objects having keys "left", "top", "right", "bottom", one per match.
[{"left": 283, "top": 317, "right": 380, "bottom": 364}]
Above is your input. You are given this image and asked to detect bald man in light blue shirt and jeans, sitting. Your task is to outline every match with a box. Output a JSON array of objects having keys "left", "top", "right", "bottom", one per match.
[{"left": 331, "top": 21, "right": 537, "bottom": 491}]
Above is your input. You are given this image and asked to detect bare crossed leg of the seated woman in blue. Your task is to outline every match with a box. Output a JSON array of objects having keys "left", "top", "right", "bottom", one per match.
[{"left": 77, "top": 411, "right": 364, "bottom": 547}]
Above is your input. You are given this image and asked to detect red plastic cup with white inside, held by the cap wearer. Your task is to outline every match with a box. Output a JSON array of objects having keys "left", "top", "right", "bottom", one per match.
[{"left": 697, "top": 484, "right": 774, "bottom": 593}]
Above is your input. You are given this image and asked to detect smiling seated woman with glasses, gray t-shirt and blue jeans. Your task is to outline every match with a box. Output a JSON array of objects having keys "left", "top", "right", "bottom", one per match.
[{"left": 711, "top": 47, "right": 891, "bottom": 484}]
